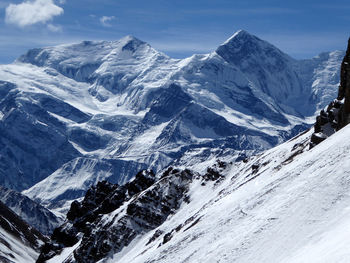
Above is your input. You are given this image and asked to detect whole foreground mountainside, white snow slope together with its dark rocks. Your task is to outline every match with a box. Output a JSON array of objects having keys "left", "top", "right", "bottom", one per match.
[{"left": 39, "top": 122, "right": 350, "bottom": 263}]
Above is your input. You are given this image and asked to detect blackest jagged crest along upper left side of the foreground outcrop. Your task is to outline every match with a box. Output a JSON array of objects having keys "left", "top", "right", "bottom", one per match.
[{"left": 37, "top": 170, "right": 159, "bottom": 263}]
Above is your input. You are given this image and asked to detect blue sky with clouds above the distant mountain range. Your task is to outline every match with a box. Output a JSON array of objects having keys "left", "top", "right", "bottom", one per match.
[{"left": 0, "top": 0, "right": 350, "bottom": 63}]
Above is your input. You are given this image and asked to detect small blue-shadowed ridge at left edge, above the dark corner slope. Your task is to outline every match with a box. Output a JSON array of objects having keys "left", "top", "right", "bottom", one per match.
[{"left": 0, "top": 186, "right": 63, "bottom": 236}]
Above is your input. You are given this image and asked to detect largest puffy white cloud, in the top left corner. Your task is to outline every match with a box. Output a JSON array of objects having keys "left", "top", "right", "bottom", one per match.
[{"left": 5, "top": 0, "right": 63, "bottom": 27}]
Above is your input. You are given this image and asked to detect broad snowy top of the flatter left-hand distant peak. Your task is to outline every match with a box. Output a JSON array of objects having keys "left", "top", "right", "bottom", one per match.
[{"left": 17, "top": 36, "right": 163, "bottom": 85}]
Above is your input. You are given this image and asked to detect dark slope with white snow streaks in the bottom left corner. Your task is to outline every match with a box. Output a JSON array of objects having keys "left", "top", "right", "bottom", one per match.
[{"left": 0, "top": 201, "right": 47, "bottom": 263}]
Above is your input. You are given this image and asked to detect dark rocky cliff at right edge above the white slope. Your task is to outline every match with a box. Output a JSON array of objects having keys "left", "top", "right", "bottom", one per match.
[{"left": 310, "top": 38, "right": 350, "bottom": 147}]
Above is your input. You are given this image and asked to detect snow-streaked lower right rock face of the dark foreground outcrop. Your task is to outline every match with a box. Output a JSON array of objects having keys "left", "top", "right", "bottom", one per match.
[{"left": 71, "top": 171, "right": 192, "bottom": 262}]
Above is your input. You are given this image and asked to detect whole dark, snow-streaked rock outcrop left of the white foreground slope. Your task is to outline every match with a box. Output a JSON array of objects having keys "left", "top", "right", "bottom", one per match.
[{"left": 37, "top": 161, "right": 227, "bottom": 263}]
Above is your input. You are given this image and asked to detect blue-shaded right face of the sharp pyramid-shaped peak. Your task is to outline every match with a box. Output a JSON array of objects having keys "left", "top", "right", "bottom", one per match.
[{"left": 215, "top": 30, "right": 310, "bottom": 115}]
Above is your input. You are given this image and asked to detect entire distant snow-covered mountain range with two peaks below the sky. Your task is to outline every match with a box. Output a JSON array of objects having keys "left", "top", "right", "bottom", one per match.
[{"left": 0, "top": 31, "right": 343, "bottom": 211}]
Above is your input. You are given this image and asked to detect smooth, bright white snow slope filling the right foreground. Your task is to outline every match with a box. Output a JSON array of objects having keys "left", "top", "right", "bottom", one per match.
[{"left": 108, "top": 126, "right": 350, "bottom": 263}]
